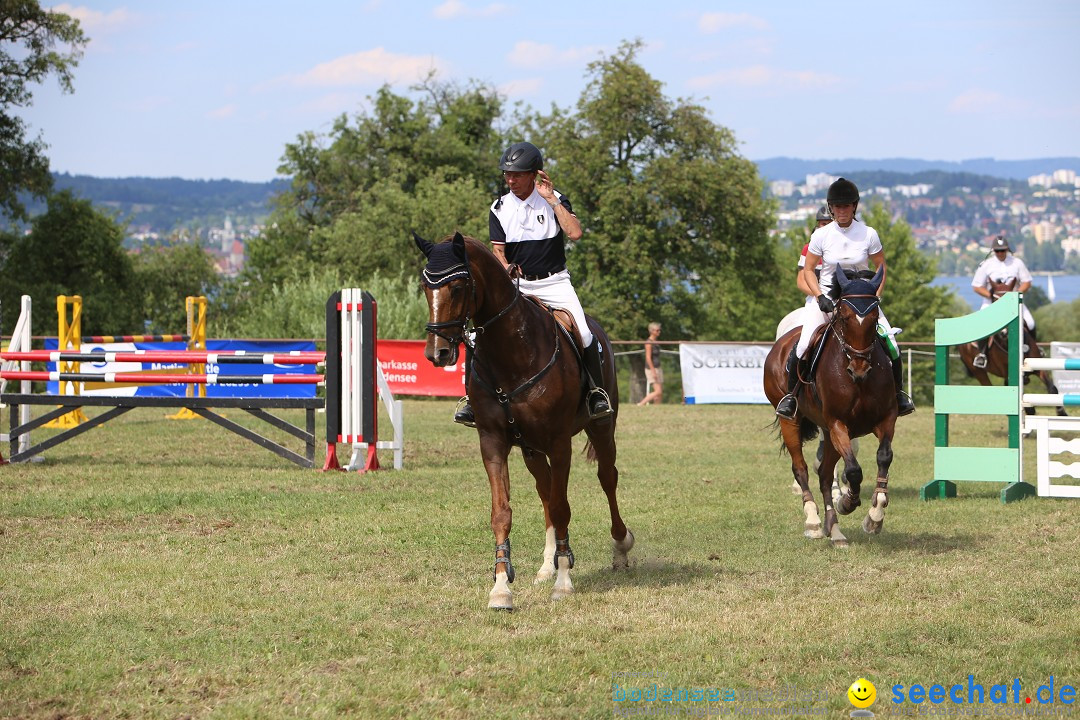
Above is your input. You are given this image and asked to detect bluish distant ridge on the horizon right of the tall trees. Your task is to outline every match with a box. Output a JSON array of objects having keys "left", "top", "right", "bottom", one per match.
[{"left": 754, "top": 158, "right": 1080, "bottom": 182}]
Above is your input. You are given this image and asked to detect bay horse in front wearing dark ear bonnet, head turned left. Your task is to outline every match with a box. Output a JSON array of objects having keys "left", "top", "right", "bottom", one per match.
[{"left": 413, "top": 232, "right": 634, "bottom": 610}]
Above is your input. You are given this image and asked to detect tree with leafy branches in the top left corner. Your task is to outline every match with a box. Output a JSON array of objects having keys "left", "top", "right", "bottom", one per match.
[{"left": 0, "top": 0, "right": 89, "bottom": 220}]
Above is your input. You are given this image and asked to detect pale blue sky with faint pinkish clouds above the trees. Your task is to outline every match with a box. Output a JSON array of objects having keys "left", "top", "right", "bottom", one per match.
[{"left": 21, "top": 0, "right": 1080, "bottom": 181}]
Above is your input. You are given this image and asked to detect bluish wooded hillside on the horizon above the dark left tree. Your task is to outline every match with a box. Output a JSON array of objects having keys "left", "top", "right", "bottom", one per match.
[{"left": 27, "top": 173, "right": 288, "bottom": 234}]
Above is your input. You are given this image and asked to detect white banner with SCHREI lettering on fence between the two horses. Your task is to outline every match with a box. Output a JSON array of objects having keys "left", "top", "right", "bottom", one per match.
[{"left": 678, "top": 342, "right": 772, "bottom": 405}]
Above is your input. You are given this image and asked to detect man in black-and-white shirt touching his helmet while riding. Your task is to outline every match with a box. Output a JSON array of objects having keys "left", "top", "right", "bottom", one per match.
[{"left": 454, "top": 142, "right": 611, "bottom": 426}]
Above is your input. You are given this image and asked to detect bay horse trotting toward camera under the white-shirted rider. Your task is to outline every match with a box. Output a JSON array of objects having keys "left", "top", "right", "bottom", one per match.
[{"left": 764, "top": 267, "right": 896, "bottom": 547}]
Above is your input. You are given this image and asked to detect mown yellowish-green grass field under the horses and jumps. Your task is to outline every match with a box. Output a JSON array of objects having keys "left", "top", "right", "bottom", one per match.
[{"left": 0, "top": 400, "right": 1080, "bottom": 719}]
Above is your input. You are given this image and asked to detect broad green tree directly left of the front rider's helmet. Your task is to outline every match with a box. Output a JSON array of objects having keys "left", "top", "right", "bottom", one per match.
[{"left": 245, "top": 77, "right": 503, "bottom": 294}]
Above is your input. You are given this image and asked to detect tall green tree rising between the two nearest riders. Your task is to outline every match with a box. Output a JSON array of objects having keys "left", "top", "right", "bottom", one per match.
[{"left": 518, "top": 41, "right": 793, "bottom": 340}]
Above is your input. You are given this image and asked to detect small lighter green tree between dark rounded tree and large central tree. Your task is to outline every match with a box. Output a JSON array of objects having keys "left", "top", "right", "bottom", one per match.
[{"left": 133, "top": 243, "right": 220, "bottom": 332}]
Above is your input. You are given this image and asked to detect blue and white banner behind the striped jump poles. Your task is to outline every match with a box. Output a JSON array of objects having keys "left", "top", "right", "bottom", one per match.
[{"left": 45, "top": 338, "right": 318, "bottom": 397}]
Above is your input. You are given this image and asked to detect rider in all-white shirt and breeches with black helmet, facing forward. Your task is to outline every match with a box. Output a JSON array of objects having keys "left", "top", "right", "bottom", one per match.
[{"left": 777, "top": 177, "right": 915, "bottom": 420}]
